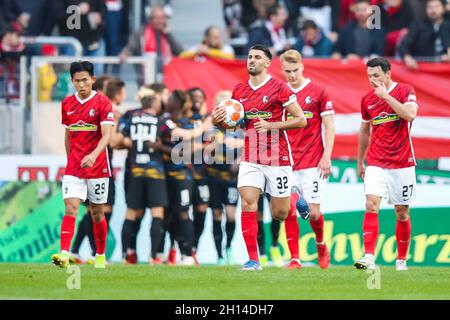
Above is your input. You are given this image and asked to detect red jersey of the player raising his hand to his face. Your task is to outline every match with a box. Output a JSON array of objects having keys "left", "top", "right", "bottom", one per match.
[{"left": 361, "top": 83, "right": 416, "bottom": 169}]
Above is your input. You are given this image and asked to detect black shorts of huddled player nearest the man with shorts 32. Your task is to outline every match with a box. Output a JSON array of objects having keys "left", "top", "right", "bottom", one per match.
[{"left": 209, "top": 180, "right": 239, "bottom": 209}]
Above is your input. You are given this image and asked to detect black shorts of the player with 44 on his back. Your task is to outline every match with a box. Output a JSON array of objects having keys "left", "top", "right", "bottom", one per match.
[{"left": 126, "top": 177, "right": 168, "bottom": 209}]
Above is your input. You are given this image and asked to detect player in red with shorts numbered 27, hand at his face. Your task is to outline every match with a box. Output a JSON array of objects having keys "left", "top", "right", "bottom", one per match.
[{"left": 355, "top": 58, "right": 418, "bottom": 271}]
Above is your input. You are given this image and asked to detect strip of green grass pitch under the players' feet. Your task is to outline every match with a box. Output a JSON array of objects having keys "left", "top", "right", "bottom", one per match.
[{"left": 0, "top": 263, "right": 450, "bottom": 300}]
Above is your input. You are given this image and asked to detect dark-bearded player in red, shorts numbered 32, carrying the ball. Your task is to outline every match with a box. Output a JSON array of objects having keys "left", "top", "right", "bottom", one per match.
[{"left": 212, "top": 45, "right": 306, "bottom": 270}]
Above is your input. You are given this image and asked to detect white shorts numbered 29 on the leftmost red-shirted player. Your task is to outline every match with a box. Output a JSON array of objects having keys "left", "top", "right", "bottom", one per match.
[{"left": 62, "top": 175, "right": 109, "bottom": 204}]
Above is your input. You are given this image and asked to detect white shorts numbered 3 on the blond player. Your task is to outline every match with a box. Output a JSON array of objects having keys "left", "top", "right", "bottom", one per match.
[{"left": 292, "top": 168, "right": 326, "bottom": 204}]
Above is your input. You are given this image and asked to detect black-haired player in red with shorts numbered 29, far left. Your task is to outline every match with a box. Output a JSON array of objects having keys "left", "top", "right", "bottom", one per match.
[{"left": 52, "top": 61, "right": 114, "bottom": 268}]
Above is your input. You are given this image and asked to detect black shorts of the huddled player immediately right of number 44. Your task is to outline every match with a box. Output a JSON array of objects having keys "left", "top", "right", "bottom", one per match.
[{"left": 166, "top": 176, "right": 194, "bottom": 211}]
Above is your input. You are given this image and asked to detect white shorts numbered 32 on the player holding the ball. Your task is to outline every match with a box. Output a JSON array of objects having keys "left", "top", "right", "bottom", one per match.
[{"left": 238, "top": 162, "right": 292, "bottom": 198}]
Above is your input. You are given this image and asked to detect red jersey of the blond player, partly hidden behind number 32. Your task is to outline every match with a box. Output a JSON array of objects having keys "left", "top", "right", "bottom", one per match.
[{"left": 287, "top": 79, "right": 334, "bottom": 170}]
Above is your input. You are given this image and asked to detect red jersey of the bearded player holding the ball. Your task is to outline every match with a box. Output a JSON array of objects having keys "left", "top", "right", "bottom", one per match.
[{"left": 232, "top": 75, "right": 297, "bottom": 166}]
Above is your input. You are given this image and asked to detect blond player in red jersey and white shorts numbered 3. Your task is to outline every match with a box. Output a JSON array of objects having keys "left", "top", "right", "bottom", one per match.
[{"left": 280, "top": 50, "right": 334, "bottom": 269}]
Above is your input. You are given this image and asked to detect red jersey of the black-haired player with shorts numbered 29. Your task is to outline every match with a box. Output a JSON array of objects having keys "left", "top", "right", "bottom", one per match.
[{"left": 61, "top": 91, "right": 114, "bottom": 179}]
